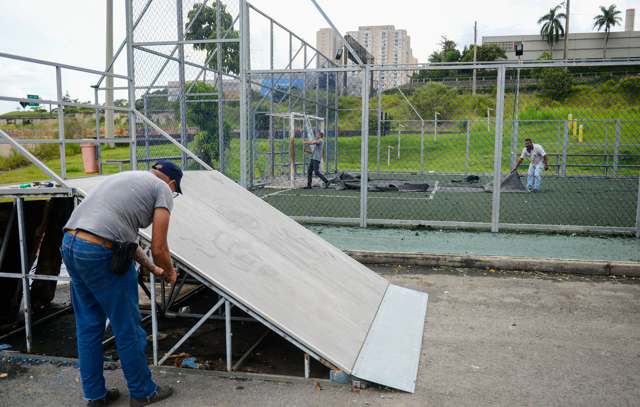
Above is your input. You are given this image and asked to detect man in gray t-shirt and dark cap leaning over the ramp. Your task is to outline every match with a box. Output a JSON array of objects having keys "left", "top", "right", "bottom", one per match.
[{"left": 61, "top": 161, "right": 182, "bottom": 406}]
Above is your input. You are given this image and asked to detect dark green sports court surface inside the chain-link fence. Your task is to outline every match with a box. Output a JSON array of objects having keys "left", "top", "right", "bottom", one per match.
[{"left": 255, "top": 174, "right": 638, "bottom": 227}]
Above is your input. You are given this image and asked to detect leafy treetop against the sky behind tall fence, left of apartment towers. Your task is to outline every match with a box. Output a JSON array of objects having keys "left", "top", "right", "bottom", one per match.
[{"left": 185, "top": 2, "right": 240, "bottom": 74}]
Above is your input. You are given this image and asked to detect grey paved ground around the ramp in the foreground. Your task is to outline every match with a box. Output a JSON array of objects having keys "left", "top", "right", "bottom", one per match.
[{"left": 0, "top": 267, "right": 640, "bottom": 407}]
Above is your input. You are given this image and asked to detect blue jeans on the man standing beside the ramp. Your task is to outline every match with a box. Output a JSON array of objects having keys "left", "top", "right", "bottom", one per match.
[{"left": 61, "top": 233, "right": 157, "bottom": 400}]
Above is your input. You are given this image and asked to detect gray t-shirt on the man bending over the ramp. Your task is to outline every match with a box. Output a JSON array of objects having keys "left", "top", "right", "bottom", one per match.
[{"left": 65, "top": 171, "right": 173, "bottom": 242}]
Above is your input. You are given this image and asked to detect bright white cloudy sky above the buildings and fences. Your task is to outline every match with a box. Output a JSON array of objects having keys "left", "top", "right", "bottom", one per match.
[{"left": 0, "top": 0, "right": 640, "bottom": 112}]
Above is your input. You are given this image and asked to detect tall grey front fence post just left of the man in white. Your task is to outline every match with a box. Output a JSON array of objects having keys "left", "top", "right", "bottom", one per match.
[{"left": 491, "top": 66, "right": 506, "bottom": 233}]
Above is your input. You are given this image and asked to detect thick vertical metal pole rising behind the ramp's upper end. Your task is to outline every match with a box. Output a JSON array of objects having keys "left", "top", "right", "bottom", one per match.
[{"left": 240, "top": 0, "right": 249, "bottom": 188}]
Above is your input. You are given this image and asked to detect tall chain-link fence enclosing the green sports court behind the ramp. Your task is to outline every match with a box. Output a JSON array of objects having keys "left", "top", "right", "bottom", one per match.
[{"left": 5, "top": 0, "right": 640, "bottom": 236}]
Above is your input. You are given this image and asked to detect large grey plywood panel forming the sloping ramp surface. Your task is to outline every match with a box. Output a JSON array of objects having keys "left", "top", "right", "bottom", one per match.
[{"left": 70, "top": 171, "right": 388, "bottom": 372}]
